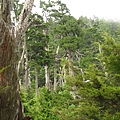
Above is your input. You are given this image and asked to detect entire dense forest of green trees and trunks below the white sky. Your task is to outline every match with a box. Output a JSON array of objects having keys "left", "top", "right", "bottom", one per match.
[{"left": 0, "top": 0, "right": 120, "bottom": 120}]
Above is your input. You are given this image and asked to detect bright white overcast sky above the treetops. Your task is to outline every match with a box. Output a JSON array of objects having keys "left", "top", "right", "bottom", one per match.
[{"left": 21, "top": 0, "right": 120, "bottom": 21}]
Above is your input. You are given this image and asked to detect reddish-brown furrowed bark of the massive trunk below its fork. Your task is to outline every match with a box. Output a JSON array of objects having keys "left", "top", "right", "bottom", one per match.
[{"left": 0, "top": 19, "right": 22, "bottom": 120}]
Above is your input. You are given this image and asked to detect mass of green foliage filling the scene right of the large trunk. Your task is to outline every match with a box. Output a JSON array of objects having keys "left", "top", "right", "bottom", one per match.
[{"left": 18, "top": 0, "right": 120, "bottom": 120}]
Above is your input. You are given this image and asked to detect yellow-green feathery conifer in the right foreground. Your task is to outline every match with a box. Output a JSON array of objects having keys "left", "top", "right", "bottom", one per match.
[{"left": 67, "top": 35, "right": 120, "bottom": 120}]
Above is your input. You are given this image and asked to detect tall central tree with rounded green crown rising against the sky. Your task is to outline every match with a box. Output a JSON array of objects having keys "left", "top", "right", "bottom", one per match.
[{"left": 41, "top": 0, "right": 81, "bottom": 90}]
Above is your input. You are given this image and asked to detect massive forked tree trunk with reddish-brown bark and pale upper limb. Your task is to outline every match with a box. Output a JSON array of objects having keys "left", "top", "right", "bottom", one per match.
[{"left": 0, "top": 0, "right": 34, "bottom": 120}]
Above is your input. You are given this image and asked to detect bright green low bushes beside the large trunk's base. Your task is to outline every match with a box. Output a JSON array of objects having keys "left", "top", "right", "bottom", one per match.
[{"left": 21, "top": 87, "right": 73, "bottom": 120}]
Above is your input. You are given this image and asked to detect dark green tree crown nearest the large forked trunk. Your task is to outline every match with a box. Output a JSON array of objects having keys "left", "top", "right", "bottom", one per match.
[{"left": 26, "top": 14, "right": 50, "bottom": 89}]
